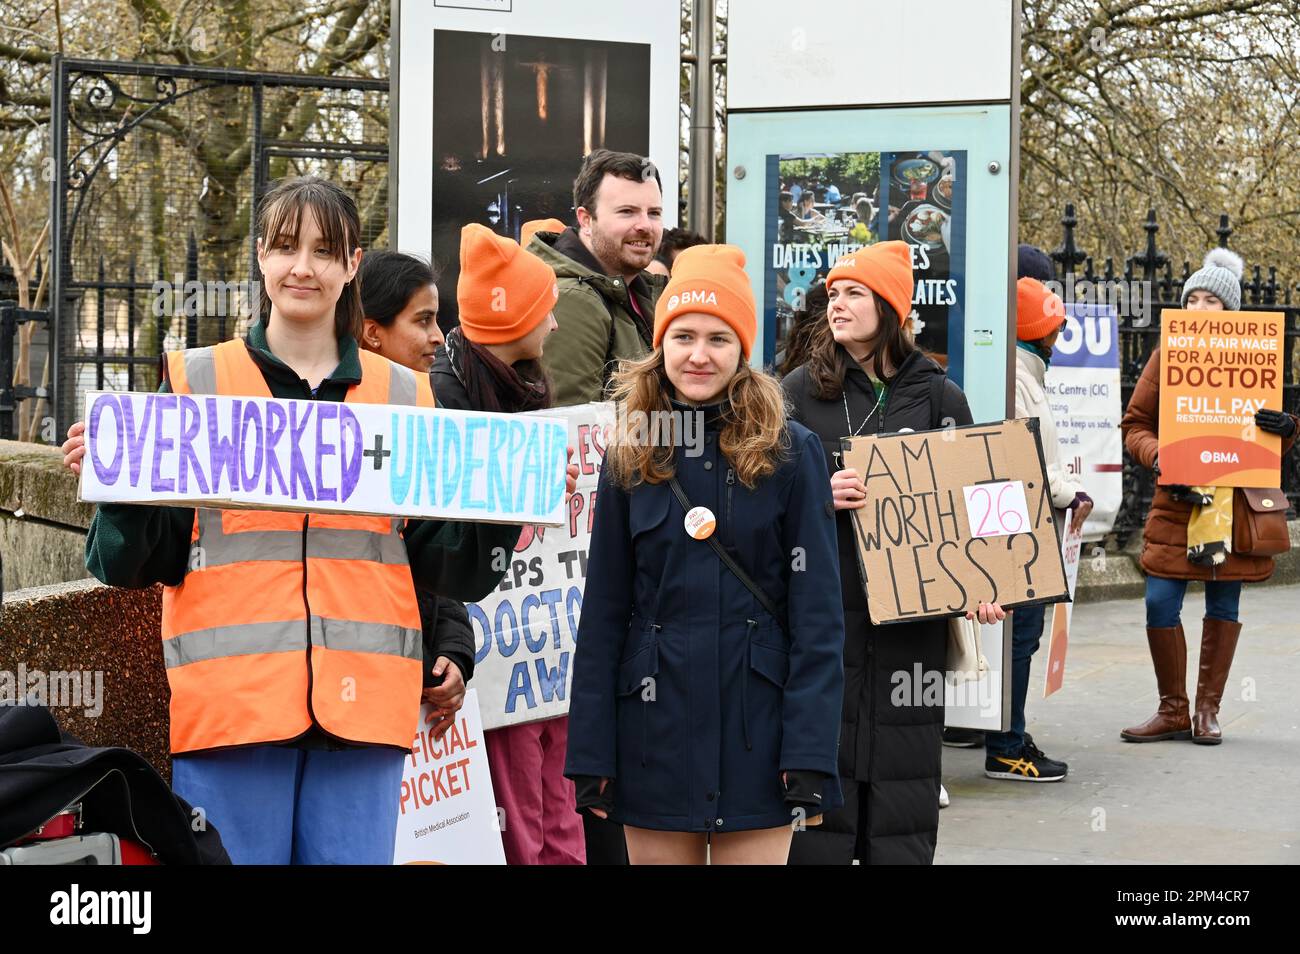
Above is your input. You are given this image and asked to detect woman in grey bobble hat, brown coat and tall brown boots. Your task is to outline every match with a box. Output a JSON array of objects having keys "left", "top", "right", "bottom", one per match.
[{"left": 1119, "top": 248, "right": 1300, "bottom": 745}]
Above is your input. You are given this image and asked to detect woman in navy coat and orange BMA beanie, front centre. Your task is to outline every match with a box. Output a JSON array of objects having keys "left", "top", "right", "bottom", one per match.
[{"left": 564, "top": 246, "right": 844, "bottom": 864}]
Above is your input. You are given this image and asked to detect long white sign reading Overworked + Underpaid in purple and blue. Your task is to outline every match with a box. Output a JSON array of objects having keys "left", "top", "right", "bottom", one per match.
[{"left": 81, "top": 391, "right": 568, "bottom": 526}]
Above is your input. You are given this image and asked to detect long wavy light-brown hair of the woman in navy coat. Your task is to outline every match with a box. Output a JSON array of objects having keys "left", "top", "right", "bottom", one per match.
[{"left": 605, "top": 347, "right": 790, "bottom": 490}]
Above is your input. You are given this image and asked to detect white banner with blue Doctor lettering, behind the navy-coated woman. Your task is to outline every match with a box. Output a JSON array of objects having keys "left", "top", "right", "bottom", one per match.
[{"left": 465, "top": 403, "right": 614, "bottom": 729}]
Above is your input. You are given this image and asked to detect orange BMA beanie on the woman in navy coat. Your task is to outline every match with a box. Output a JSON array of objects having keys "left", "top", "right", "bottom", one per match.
[{"left": 654, "top": 246, "right": 758, "bottom": 360}]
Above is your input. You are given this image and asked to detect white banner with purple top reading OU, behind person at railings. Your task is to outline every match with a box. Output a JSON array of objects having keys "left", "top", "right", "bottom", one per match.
[{"left": 1044, "top": 302, "right": 1125, "bottom": 541}]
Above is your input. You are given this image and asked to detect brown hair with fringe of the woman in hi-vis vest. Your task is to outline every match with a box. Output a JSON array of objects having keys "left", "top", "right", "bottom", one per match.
[{"left": 257, "top": 175, "right": 363, "bottom": 339}]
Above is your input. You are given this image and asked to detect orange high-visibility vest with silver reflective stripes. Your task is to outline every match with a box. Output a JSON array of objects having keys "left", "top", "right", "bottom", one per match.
[{"left": 163, "top": 341, "right": 433, "bottom": 754}]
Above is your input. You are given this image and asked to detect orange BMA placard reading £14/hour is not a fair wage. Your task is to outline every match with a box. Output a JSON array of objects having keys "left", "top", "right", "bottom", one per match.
[{"left": 1160, "top": 311, "right": 1286, "bottom": 487}]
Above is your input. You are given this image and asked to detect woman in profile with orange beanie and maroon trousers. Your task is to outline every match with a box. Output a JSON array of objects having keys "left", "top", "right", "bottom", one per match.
[{"left": 430, "top": 225, "right": 586, "bottom": 864}]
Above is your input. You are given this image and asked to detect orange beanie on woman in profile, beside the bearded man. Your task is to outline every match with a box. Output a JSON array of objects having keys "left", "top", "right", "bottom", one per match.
[{"left": 456, "top": 225, "right": 560, "bottom": 344}]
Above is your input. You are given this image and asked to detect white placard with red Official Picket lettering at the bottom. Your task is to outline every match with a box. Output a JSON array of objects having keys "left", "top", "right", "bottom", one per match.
[{"left": 393, "top": 689, "right": 506, "bottom": 864}]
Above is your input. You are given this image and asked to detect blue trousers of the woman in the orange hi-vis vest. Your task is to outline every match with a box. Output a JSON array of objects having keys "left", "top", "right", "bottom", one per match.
[{"left": 172, "top": 745, "right": 406, "bottom": 864}]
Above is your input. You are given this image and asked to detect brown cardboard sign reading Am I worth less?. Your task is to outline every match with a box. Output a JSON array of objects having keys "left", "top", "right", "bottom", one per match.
[{"left": 844, "top": 417, "right": 1069, "bottom": 624}]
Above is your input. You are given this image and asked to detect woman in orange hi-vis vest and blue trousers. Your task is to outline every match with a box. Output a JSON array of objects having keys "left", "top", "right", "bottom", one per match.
[{"left": 64, "top": 177, "right": 519, "bottom": 864}]
